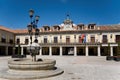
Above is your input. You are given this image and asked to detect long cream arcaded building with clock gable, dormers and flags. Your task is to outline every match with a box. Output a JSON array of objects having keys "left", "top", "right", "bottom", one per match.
[{"left": 0, "top": 16, "right": 120, "bottom": 56}]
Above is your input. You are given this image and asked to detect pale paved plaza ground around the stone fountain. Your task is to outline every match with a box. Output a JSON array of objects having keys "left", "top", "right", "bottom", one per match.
[{"left": 0, "top": 56, "right": 120, "bottom": 80}]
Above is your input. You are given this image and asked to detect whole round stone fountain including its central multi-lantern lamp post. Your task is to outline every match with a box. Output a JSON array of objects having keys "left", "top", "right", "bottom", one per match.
[{"left": 0, "top": 10, "right": 64, "bottom": 80}]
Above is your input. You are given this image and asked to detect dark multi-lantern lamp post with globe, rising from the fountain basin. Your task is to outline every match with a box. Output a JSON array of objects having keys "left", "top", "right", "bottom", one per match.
[{"left": 27, "top": 10, "right": 40, "bottom": 61}]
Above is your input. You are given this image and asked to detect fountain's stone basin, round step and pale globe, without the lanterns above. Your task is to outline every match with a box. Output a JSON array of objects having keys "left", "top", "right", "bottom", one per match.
[{"left": 0, "top": 43, "right": 64, "bottom": 79}]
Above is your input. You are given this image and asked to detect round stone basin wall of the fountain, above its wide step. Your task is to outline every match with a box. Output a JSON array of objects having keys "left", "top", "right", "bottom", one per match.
[{"left": 8, "top": 59, "right": 56, "bottom": 70}]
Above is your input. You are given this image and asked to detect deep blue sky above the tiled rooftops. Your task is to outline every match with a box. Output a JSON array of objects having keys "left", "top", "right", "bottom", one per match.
[{"left": 0, "top": 0, "right": 120, "bottom": 29}]
